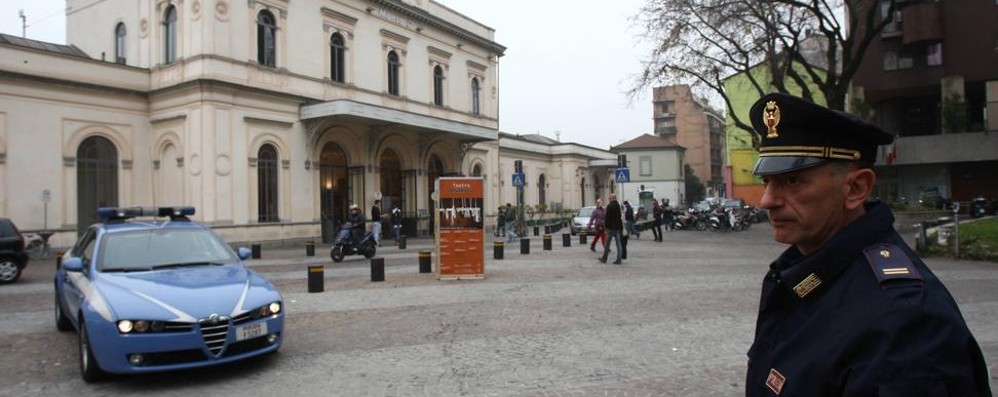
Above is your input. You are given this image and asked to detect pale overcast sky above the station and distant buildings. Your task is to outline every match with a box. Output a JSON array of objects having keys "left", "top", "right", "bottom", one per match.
[{"left": 0, "top": 0, "right": 653, "bottom": 149}]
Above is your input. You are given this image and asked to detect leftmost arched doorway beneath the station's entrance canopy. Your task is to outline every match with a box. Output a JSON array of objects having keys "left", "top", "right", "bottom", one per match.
[{"left": 319, "top": 142, "right": 349, "bottom": 243}]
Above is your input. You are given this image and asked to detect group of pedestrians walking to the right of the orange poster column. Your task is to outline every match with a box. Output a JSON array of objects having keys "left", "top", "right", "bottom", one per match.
[{"left": 588, "top": 194, "right": 672, "bottom": 265}]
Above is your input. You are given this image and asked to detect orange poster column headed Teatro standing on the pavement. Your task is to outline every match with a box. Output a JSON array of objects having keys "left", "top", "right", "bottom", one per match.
[{"left": 434, "top": 177, "right": 485, "bottom": 280}]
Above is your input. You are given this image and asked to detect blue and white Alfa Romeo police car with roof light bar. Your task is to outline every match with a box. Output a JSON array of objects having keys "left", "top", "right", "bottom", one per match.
[{"left": 55, "top": 207, "right": 284, "bottom": 382}]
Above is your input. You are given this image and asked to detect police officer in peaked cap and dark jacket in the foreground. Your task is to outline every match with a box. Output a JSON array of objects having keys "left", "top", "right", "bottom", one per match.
[{"left": 745, "top": 94, "right": 991, "bottom": 396}]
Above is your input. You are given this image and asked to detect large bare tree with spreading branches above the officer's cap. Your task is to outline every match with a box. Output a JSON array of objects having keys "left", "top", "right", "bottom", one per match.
[{"left": 630, "top": 0, "right": 897, "bottom": 147}]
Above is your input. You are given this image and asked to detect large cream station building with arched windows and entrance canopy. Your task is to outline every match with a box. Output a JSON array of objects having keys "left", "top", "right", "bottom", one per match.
[{"left": 0, "top": 0, "right": 505, "bottom": 246}]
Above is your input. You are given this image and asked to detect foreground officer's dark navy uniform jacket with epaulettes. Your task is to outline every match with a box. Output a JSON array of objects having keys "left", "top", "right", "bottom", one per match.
[{"left": 746, "top": 203, "right": 991, "bottom": 396}]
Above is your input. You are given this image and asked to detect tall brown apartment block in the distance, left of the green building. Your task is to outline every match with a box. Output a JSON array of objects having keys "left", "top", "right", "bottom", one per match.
[{"left": 652, "top": 85, "right": 727, "bottom": 196}]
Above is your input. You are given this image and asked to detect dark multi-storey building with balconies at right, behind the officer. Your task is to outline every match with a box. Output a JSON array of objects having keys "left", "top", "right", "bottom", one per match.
[{"left": 852, "top": 1, "right": 998, "bottom": 202}]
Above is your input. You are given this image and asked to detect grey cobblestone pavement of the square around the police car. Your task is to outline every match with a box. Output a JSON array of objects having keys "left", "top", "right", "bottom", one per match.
[{"left": 0, "top": 224, "right": 998, "bottom": 396}]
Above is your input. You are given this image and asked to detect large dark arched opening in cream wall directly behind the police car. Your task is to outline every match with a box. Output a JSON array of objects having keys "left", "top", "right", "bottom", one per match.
[{"left": 76, "top": 136, "right": 118, "bottom": 234}]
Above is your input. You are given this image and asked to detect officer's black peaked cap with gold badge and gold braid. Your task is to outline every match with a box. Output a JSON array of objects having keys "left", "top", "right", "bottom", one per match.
[{"left": 749, "top": 93, "right": 894, "bottom": 175}]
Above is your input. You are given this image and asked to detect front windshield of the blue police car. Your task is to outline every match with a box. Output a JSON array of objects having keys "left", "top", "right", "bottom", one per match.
[{"left": 98, "top": 229, "right": 234, "bottom": 272}]
